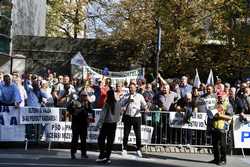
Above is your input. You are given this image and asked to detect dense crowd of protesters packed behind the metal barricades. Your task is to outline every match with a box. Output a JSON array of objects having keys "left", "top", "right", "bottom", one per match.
[{"left": 0, "top": 72, "right": 250, "bottom": 121}]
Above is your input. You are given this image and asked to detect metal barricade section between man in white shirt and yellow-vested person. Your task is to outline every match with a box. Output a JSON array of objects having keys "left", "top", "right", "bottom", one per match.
[{"left": 142, "top": 111, "right": 212, "bottom": 147}]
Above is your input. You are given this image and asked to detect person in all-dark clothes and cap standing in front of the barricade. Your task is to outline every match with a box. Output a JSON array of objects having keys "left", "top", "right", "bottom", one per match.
[{"left": 67, "top": 91, "right": 94, "bottom": 159}]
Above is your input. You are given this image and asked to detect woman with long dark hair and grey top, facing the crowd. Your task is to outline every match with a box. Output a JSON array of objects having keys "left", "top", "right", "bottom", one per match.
[{"left": 96, "top": 89, "right": 121, "bottom": 164}]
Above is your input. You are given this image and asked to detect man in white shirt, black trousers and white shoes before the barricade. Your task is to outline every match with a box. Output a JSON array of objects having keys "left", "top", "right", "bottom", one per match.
[{"left": 122, "top": 83, "right": 148, "bottom": 157}]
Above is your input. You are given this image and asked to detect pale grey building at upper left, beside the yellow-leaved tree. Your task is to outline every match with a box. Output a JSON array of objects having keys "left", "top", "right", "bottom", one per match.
[{"left": 0, "top": 0, "right": 46, "bottom": 73}]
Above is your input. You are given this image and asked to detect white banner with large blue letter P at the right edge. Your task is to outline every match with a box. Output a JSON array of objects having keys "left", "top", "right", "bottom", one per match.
[{"left": 233, "top": 115, "right": 250, "bottom": 148}]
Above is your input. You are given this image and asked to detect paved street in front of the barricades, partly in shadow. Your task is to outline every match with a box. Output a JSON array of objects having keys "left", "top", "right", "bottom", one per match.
[{"left": 0, "top": 149, "right": 250, "bottom": 167}]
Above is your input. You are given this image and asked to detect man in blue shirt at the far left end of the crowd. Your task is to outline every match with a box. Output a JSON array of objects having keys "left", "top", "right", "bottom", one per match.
[{"left": 0, "top": 75, "right": 22, "bottom": 107}]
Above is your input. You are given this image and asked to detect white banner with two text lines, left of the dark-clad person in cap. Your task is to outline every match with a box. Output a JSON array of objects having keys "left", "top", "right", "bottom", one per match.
[{"left": 20, "top": 107, "right": 59, "bottom": 124}]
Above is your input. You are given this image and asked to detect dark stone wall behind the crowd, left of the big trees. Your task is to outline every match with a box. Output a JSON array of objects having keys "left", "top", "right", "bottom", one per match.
[{"left": 13, "top": 36, "right": 137, "bottom": 74}]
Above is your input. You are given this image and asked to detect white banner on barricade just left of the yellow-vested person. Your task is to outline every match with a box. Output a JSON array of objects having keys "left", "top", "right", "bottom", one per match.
[{"left": 169, "top": 112, "right": 207, "bottom": 130}]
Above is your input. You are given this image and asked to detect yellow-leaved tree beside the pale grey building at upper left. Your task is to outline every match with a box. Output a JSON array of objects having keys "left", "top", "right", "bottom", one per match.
[{"left": 46, "top": 0, "right": 90, "bottom": 38}]
